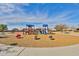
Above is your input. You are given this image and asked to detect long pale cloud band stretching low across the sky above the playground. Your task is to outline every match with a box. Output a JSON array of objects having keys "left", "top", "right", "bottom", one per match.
[{"left": 0, "top": 11, "right": 74, "bottom": 24}]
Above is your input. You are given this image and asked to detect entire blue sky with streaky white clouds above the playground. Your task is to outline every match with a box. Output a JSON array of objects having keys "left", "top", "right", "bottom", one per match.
[{"left": 0, "top": 3, "right": 79, "bottom": 29}]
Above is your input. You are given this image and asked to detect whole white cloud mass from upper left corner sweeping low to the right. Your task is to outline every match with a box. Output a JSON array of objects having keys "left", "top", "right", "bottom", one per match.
[{"left": 0, "top": 4, "right": 78, "bottom": 28}]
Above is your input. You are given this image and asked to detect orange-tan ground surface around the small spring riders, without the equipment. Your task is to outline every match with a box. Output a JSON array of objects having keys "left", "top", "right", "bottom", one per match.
[{"left": 0, "top": 32, "right": 79, "bottom": 47}]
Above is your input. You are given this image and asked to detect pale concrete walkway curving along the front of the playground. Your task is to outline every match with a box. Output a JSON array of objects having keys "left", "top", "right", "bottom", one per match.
[{"left": 0, "top": 44, "right": 79, "bottom": 56}]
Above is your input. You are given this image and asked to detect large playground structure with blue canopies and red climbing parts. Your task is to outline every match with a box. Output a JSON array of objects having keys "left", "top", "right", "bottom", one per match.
[{"left": 23, "top": 24, "right": 48, "bottom": 35}]
